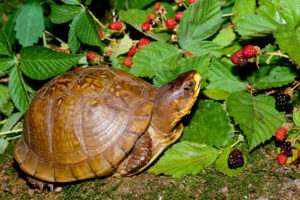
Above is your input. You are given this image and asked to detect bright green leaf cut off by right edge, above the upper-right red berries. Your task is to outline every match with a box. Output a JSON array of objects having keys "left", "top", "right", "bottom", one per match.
[{"left": 274, "top": 25, "right": 300, "bottom": 66}]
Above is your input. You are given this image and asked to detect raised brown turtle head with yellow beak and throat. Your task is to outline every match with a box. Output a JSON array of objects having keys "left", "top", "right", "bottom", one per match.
[{"left": 153, "top": 71, "right": 201, "bottom": 133}]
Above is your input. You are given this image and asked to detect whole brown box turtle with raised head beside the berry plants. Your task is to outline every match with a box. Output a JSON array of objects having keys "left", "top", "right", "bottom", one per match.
[{"left": 14, "top": 66, "right": 201, "bottom": 182}]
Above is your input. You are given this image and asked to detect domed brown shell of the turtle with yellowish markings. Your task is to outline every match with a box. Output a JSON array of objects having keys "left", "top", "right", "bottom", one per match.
[{"left": 14, "top": 67, "right": 157, "bottom": 182}]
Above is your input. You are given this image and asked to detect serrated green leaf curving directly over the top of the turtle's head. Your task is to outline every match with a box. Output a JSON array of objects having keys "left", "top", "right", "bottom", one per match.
[{"left": 153, "top": 56, "right": 210, "bottom": 87}]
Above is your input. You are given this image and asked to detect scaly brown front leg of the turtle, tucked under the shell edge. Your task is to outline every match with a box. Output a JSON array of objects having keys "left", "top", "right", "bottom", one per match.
[{"left": 115, "top": 132, "right": 152, "bottom": 176}]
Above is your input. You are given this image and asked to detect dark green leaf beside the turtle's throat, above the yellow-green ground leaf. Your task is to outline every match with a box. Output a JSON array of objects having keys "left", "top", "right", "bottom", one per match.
[{"left": 181, "top": 100, "right": 233, "bottom": 147}]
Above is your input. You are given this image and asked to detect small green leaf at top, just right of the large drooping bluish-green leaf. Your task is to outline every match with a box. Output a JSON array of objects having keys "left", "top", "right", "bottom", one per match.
[{"left": 49, "top": 4, "right": 83, "bottom": 24}]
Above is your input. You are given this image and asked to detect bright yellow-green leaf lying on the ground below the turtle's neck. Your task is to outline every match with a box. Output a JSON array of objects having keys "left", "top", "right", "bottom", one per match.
[{"left": 149, "top": 141, "right": 219, "bottom": 178}]
